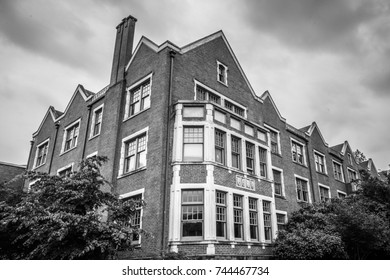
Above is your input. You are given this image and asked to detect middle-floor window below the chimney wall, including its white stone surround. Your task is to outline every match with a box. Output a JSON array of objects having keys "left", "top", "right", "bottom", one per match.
[{"left": 119, "top": 127, "right": 149, "bottom": 176}]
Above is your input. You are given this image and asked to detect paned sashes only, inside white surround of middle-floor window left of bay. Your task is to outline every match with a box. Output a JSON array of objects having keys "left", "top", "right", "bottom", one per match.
[{"left": 124, "top": 134, "right": 146, "bottom": 173}]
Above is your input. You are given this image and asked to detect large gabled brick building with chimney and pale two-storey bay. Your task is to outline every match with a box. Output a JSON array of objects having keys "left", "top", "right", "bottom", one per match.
[{"left": 26, "top": 16, "right": 359, "bottom": 258}]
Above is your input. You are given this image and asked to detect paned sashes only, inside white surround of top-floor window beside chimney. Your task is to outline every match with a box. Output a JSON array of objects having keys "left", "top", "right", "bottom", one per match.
[{"left": 128, "top": 79, "right": 151, "bottom": 116}]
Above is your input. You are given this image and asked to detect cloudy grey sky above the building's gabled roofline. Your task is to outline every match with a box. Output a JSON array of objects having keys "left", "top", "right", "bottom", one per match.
[{"left": 0, "top": 0, "right": 390, "bottom": 170}]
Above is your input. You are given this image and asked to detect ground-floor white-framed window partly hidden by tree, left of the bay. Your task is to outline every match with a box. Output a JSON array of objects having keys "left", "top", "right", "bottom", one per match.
[{"left": 119, "top": 188, "right": 145, "bottom": 245}]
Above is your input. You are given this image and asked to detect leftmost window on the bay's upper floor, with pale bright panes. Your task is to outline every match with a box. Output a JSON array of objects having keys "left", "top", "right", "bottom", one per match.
[{"left": 183, "top": 127, "right": 203, "bottom": 161}]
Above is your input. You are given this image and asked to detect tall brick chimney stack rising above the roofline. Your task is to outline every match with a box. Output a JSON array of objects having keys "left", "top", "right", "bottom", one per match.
[{"left": 110, "top": 16, "right": 137, "bottom": 85}]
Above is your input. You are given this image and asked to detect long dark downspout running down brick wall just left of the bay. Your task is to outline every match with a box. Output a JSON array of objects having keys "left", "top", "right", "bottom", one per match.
[{"left": 161, "top": 50, "right": 176, "bottom": 256}]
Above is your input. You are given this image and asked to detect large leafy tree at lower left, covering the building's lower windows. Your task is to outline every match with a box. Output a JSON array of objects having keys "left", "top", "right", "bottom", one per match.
[{"left": 0, "top": 157, "right": 144, "bottom": 259}]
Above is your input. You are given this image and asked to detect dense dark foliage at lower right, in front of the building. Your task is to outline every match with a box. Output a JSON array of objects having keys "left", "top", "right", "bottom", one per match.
[{"left": 274, "top": 174, "right": 390, "bottom": 259}]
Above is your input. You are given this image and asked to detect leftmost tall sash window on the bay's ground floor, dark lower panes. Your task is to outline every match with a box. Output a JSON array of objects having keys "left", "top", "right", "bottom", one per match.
[{"left": 181, "top": 190, "right": 203, "bottom": 237}]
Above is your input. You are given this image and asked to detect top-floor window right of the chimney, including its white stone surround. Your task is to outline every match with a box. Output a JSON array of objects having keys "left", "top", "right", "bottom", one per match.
[{"left": 124, "top": 74, "right": 152, "bottom": 120}]
